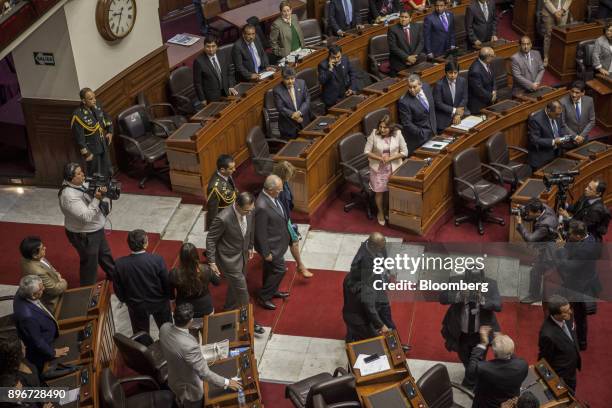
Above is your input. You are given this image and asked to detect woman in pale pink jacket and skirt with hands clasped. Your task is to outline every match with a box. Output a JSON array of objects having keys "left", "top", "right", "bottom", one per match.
[{"left": 364, "top": 115, "right": 408, "bottom": 225}]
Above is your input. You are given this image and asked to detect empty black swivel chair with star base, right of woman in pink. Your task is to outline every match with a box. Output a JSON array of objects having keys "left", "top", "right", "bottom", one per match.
[{"left": 453, "top": 147, "right": 508, "bottom": 235}]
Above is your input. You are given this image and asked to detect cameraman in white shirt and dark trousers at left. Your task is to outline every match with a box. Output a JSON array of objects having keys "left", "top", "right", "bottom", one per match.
[{"left": 58, "top": 163, "right": 115, "bottom": 286}]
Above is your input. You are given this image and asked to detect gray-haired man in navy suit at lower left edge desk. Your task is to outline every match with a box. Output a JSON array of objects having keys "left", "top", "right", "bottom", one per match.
[{"left": 13, "top": 275, "right": 69, "bottom": 373}]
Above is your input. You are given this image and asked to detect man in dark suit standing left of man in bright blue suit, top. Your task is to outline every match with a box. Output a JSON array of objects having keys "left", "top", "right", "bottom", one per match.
[{"left": 387, "top": 10, "right": 425, "bottom": 75}]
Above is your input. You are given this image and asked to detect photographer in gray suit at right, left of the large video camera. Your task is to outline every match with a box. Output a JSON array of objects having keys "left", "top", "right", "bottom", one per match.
[{"left": 514, "top": 198, "right": 559, "bottom": 303}]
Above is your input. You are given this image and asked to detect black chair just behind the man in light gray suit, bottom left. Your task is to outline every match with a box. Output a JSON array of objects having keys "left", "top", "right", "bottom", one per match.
[{"left": 113, "top": 332, "right": 168, "bottom": 385}]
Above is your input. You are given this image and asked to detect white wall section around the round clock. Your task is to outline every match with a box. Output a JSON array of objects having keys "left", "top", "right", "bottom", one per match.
[{"left": 64, "top": 0, "right": 162, "bottom": 89}]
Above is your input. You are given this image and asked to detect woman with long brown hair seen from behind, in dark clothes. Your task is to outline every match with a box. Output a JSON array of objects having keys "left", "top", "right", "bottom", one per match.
[{"left": 170, "top": 243, "right": 221, "bottom": 318}]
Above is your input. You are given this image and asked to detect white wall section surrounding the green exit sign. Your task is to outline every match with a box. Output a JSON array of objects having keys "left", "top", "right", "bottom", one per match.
[{"left": 13, "top": 7, "right": 80, "bottom": 100}]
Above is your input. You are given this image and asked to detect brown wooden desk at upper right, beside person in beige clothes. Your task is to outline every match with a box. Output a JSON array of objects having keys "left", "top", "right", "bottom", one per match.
[{"left": 549, "top": 22, "right": 603, "bottom": 83}]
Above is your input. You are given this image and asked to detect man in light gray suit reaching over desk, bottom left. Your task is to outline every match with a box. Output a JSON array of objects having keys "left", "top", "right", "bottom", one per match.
[{"left": 159, "top": 303, "right": 241, "bottom": 408}]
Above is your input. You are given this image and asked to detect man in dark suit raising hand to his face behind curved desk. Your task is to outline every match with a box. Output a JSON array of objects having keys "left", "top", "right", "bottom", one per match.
[{"left": 318, "top": 45, "right": 358, "bottom": 108}]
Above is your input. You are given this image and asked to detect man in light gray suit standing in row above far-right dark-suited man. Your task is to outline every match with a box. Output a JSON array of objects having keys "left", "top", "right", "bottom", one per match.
[{"left": 512, "top": 36, "right": 544, "bottom": 96}]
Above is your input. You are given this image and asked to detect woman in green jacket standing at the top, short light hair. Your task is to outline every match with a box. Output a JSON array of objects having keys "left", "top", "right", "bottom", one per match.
[{"left": 270, "top": 1, "right": 304, "bottom": 58}]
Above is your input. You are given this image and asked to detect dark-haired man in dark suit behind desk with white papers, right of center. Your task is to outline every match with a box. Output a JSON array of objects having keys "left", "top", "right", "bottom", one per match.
[{"left": 434, "top": 61, "right": 470, "bottom": 133}]
